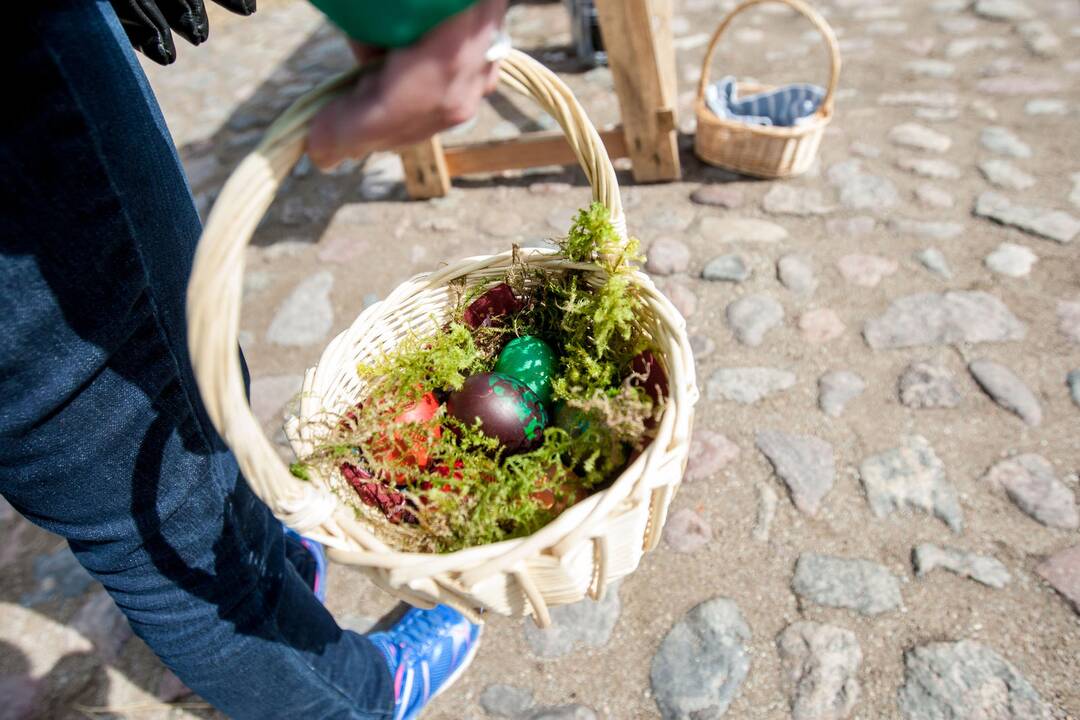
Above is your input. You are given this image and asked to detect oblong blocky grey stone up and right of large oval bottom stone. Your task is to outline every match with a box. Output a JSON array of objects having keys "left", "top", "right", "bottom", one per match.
[{"left": 792, "top": 553, "right": 902, "bottom": 615}]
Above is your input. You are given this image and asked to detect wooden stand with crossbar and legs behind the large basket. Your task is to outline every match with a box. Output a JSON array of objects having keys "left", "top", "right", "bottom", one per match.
[{"left": 399, "top": 0, "right": 681, "bottom": 200}]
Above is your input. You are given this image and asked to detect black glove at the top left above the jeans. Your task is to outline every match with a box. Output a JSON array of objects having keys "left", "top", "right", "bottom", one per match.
[{"left": 109, "top": 0, "right": 255, "bottom": 65}]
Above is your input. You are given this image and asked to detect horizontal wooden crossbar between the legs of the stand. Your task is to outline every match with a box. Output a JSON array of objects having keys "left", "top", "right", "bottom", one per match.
[{"left": 442, "top": 127, "right": 626, "bottom": 175}]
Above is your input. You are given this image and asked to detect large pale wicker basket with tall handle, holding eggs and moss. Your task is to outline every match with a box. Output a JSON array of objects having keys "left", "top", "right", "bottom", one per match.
[{"left": 188, "top": 52, "right": 698, "bottom": 626}]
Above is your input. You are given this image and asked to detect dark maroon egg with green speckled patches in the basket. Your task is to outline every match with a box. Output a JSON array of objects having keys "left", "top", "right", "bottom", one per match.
[{"left": 446, "top": 372, "right": 548, "bottom": 452}]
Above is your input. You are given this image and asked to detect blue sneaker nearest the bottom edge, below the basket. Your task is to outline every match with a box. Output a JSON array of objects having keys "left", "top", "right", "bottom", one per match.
[{"left": 367, "top": 604, "right": 481, "bottom": 720}]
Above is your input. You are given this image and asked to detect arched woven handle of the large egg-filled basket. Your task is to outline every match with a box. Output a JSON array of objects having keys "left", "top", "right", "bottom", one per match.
[{"left": 187, "top": 51, "right": 626, "bottom": 539}]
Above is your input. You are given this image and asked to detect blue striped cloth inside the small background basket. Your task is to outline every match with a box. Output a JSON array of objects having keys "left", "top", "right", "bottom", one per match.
[{"left": 705, "top": 76, "right": 825, "bottom": 126}]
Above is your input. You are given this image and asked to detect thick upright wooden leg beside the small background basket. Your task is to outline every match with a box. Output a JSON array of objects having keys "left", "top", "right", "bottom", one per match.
[{"left": 596, "top": 0, "right": 681, "bottom": 182}]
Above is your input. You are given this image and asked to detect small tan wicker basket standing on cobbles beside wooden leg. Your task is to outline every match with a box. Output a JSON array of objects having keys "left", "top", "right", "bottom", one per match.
[{"left": 693, "top": 0, "right": 840, "bottom": 178}]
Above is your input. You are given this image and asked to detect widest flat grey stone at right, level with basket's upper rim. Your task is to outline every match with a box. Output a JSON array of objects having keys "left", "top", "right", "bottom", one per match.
[{"left": 863, "top": 290, "right": 1027, "bottom": 350}]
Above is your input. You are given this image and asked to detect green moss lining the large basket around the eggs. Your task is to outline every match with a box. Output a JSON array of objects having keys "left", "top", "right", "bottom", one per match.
[{"left": 294, "top": 204, "right": 659, "bottom": 552}]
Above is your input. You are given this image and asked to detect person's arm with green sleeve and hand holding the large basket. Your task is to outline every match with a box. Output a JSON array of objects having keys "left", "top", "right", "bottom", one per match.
[{"left": 308, "top": 0, "right": 507, "bottom": 169}]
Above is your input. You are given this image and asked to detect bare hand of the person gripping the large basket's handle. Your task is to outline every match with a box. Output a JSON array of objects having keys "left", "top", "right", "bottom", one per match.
[{"left": 308, "top": 0, "right": 507, "bottom": 169}]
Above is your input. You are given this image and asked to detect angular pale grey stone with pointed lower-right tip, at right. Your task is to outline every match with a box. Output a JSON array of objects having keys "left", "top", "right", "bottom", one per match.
[{"left": 859, "top": 435, "right": 963, "bottom": 533}]
